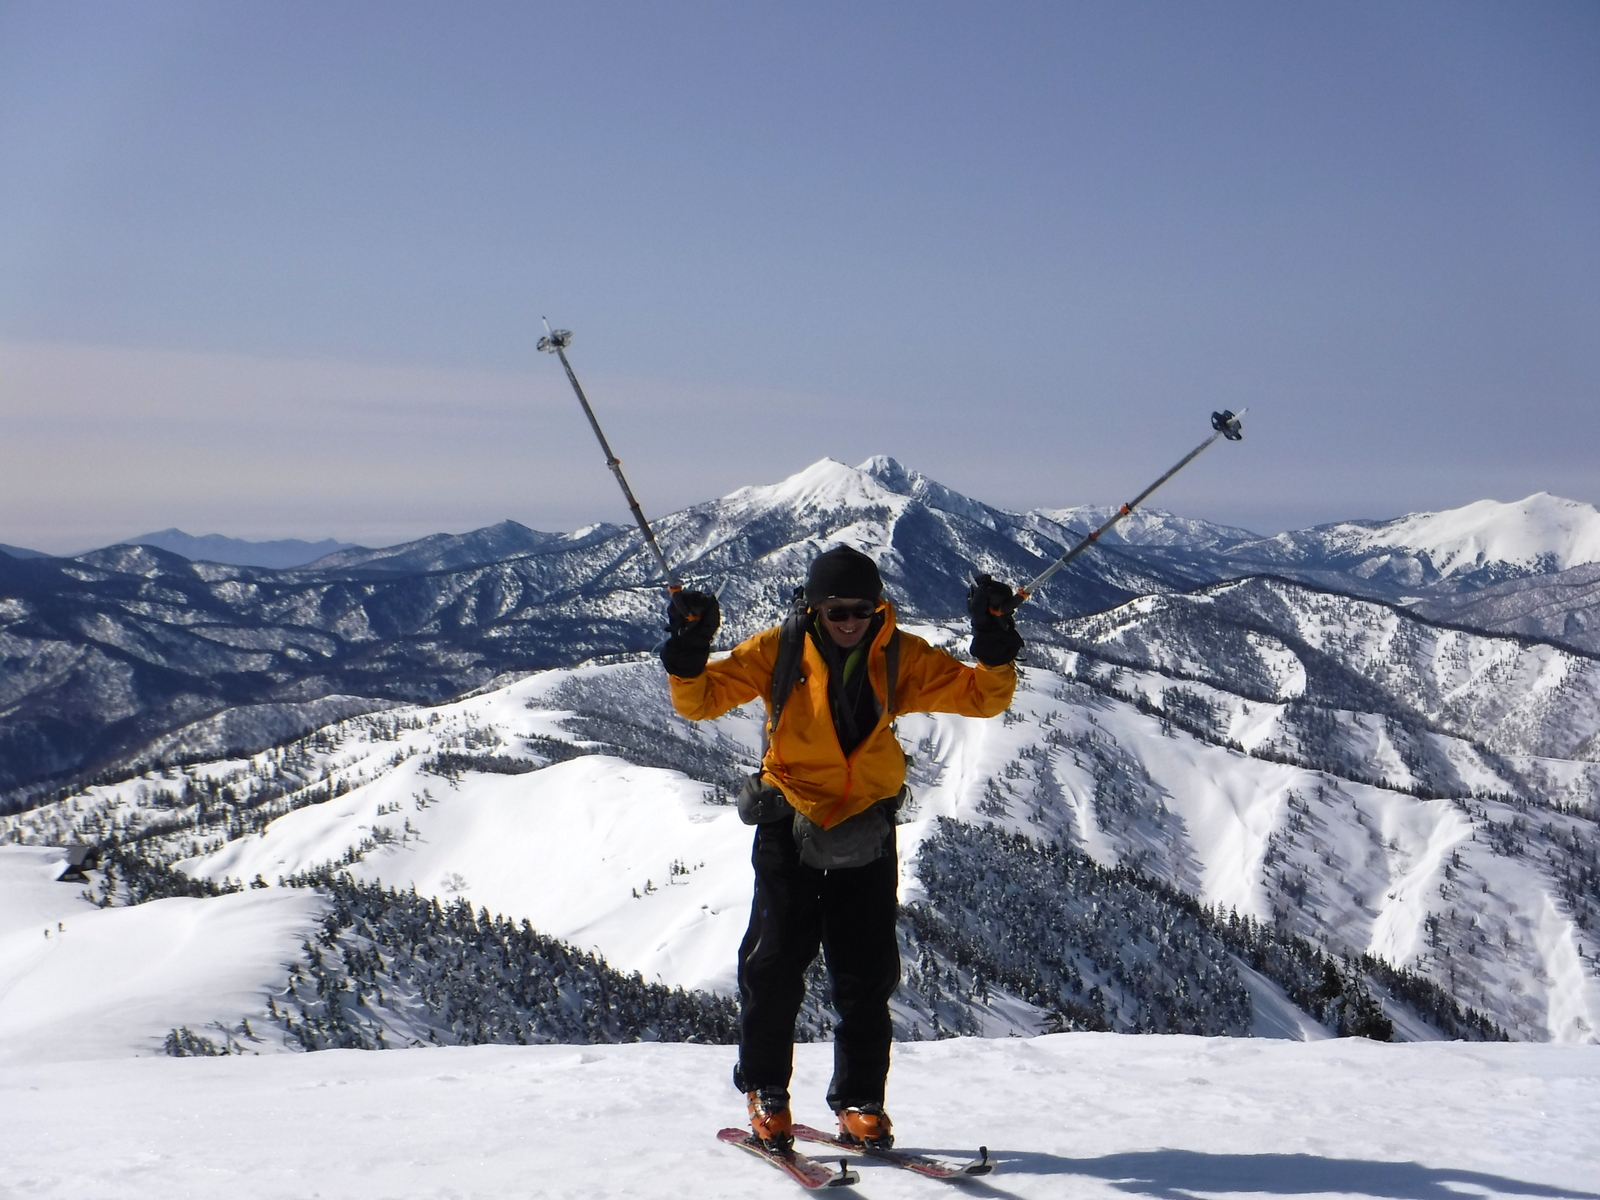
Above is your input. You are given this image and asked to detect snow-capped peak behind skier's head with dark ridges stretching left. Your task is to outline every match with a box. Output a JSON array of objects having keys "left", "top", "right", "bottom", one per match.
[{"left": 0, "top": 459, "right": 1210, "bottom": 808}]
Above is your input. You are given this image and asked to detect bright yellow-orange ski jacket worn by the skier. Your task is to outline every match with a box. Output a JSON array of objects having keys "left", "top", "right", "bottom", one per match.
[{"left": 667, "top": 603, "right": 1016, "bottom": 829}]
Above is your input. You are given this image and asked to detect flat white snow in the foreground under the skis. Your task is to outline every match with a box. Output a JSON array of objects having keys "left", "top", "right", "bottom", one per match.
[{"left": 0, "top": 1034, "right": 1600, "bottom": 1200}]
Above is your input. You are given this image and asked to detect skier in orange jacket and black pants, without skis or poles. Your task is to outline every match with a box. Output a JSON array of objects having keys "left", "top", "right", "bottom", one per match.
[{"left": 661, "top": 546, "right": 1022, "bottom": 1152}]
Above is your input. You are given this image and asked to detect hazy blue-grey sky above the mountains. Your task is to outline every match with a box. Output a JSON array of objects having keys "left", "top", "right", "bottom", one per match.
[{"left": 0, "top": 0, "right": 1600, "bottom": 552}]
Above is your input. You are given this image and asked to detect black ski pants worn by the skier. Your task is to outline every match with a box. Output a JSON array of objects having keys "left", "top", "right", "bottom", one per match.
[{"left": 734, "top": 821, "right": 901, "bottom": 1110}]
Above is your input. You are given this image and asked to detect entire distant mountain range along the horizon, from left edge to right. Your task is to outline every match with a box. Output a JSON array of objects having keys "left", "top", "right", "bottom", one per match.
[{"left": 0, "top": 458, "right": 1600, "bottom": 808}]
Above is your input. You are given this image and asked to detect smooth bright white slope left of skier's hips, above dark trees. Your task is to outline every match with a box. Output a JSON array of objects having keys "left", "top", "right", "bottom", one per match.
[{"left": 208, "top": 748, "right": 750, "bottom": 994}]
